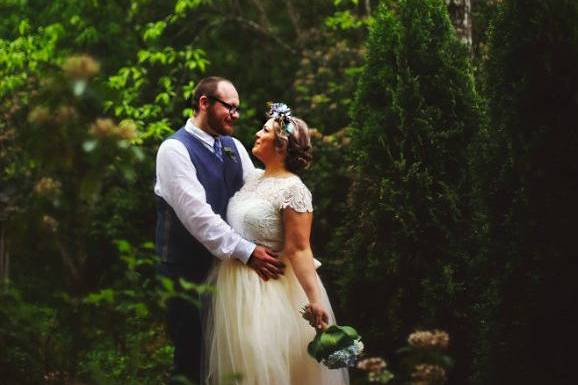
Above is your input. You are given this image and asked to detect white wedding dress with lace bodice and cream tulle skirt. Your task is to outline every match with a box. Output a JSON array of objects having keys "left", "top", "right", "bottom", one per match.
[{"left": 205, "top": 170, "right": 349, "bottom": 385}]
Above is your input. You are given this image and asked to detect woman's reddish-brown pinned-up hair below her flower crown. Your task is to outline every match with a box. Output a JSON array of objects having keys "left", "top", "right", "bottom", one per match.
[{"left": 275, "top": 116, "right": 313, "bottom": 174}]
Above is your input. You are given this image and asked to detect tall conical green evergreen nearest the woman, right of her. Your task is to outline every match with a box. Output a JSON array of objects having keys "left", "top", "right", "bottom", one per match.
[{"left": 338, "top": 0, "right": 480, "bottom": 378}]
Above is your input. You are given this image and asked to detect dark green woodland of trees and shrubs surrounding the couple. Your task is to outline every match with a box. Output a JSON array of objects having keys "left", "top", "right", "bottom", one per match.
[{"left": 0, "top": 0, "right": 578, "bottom": 385}]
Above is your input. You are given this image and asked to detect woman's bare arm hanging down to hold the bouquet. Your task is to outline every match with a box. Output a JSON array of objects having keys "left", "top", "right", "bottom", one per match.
[{"left": 283, "top": 207, "right": 329, "bottom": 328}]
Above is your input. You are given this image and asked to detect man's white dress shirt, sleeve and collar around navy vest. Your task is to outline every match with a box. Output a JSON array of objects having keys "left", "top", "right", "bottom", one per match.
[{"left": 155, "top": 119, "right": 256, "bottom": 263}]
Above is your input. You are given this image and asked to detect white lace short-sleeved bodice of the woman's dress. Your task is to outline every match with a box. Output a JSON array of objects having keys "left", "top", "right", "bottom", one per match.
[{"left": 227, "top": 170, "right": 313, "bottom": 251}]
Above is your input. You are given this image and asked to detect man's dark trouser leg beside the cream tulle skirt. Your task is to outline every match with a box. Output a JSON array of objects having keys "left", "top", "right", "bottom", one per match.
[{"left": 167, "top": 298, "right": 203, "bottom": 385}]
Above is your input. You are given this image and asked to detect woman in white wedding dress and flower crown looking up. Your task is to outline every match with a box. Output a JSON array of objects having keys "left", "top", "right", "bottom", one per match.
[{"left": 205, "top": 103, "right": 349, "bottom": 385}]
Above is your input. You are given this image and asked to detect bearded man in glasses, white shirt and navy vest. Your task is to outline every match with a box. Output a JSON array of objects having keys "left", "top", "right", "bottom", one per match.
[{"left": 154, "top": 76, "right": 283, "bottom": 384}]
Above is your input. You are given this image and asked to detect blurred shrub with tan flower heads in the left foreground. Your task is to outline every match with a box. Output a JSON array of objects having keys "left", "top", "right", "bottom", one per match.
[{"left": 5, "top": 56, "right": 144, "bottom": 292}]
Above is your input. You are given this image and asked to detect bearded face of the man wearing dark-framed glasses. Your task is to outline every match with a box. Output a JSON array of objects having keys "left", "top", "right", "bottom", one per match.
[{"left": 207, "top": 82, "right": 239, "bottom": 135}]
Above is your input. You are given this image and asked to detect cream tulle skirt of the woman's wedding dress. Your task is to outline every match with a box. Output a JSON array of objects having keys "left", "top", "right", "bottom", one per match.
[{"left": 204, "top": 255, "right": 349, "bottom": 385}]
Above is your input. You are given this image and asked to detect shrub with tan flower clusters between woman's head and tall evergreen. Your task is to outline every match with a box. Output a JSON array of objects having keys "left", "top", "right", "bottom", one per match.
[{"left": 292, "top": 2, "right": 371, "bottom": 292}]
